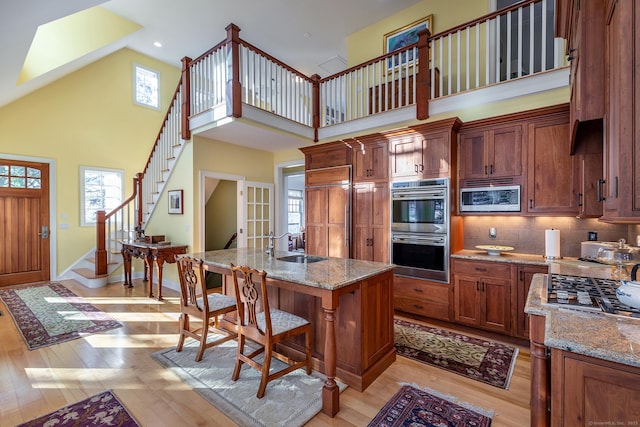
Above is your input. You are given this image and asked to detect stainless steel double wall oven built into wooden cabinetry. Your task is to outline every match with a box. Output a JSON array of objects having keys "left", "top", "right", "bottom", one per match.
[{"left": 391, "top": 179, "right": 450, "bottom": 282}]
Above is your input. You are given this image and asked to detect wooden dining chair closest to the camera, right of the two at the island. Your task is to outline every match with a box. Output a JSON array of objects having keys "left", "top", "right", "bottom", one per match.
[{"left": 231, "top": 264, "right": 311, "bottom": 399}]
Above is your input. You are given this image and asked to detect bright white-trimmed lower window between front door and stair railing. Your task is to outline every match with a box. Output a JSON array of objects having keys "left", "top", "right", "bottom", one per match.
[{"left": 80, "top": 167, "right": 124, "bottom": 226}]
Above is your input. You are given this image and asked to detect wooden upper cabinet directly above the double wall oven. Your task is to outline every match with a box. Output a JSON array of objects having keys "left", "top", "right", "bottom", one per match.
[{"left": 385, "top": 118, "right": 461, "bottom": 180}]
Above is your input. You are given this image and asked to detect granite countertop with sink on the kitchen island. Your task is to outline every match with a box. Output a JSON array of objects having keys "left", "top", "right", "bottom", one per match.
[{"left": 190, "top": 248, "right": 394, "bottom": 290}]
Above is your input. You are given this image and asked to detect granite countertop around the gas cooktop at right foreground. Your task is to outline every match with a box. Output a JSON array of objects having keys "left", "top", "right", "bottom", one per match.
[{"left": 524, "top": 274, "right": 640, "bottom": 367}]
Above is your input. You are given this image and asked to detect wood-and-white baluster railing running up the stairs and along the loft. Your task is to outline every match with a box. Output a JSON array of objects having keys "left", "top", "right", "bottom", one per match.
[{"left": 96, "top": 0, "right": 566, "bottom": 274}]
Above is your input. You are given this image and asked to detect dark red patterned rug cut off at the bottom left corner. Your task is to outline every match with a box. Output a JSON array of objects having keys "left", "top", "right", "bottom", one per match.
[{"left": 17, "top": 390, "right": 140, "bottom": 427}]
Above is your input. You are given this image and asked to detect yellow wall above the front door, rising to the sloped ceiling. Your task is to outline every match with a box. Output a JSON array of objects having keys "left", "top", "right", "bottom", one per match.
[{"left": 0, "top": 49, "right": 180, "bottom": 274}]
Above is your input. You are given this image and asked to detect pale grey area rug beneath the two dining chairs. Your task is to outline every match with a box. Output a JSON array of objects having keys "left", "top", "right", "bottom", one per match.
[{"left": 151, "top": 335, "right": 346, "bottom": 427}]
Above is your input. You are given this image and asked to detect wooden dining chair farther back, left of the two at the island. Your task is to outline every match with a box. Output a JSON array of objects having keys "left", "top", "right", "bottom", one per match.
[{"left": 176, "top": 256, "right": 237, "bottom": 362}]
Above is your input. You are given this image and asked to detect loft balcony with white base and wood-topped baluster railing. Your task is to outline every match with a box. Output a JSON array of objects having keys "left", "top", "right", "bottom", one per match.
[{"left": 179, "top": 0, "right": 569, "bottom": 151}]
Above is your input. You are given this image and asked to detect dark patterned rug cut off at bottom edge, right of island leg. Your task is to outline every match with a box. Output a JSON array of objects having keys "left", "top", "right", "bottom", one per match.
[{"left": 369, "top": 385, "right": 493, "bottom": 427}]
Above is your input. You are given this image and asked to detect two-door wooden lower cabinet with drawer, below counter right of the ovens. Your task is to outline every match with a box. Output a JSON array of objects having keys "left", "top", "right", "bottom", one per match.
[{"left": 452, "top": 259, "right": 513, "bottom": 334}]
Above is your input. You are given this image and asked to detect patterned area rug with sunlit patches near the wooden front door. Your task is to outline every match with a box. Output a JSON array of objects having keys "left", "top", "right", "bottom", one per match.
[{"left": 0, "top": 282, "right": 122, "bottom": 350}]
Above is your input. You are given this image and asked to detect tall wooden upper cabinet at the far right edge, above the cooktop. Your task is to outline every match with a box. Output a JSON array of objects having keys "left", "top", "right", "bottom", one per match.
[{"left": 601, "top": 0, "right": 640, "bottom": 223}]
